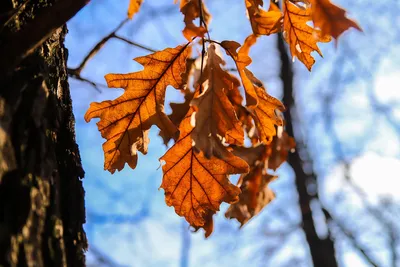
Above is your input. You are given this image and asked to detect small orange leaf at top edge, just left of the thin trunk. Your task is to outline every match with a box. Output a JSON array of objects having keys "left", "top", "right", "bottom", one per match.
[{"left": 245, "top": 0, "right": 283, "bottom": 35}]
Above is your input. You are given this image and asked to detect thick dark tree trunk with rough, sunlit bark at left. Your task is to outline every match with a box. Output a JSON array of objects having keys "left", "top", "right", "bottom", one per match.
[{"left": 0, "top": 0, "right": 87, "bottom": 267}]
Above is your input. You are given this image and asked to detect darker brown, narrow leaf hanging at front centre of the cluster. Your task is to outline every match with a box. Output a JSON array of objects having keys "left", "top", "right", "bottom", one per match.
[{"left": 192, "top": 44, "right": 244, "bottom": 158}]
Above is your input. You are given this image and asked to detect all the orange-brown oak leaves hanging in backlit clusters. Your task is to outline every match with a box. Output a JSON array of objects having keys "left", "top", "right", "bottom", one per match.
[{"left": 85, "top": 0, "right": 361, "bottom": 236}]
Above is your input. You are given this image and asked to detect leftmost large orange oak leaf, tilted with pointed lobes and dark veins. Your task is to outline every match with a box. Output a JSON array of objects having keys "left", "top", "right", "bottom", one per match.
[{"left": 85, "top": 45, "right": 190, "bottom": 173}]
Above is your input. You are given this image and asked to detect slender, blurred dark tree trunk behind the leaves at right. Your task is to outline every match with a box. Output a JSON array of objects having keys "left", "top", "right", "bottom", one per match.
[{"left": 278, "top": 36, "right": 338, "bottom": 267}]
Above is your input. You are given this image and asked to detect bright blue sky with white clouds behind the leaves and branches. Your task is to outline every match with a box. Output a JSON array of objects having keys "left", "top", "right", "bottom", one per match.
[{"left": 66, "top": 0, "right": 400, "bottom": 266}]
